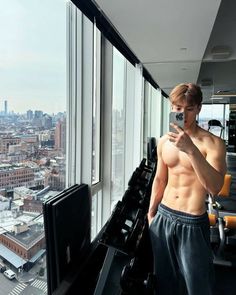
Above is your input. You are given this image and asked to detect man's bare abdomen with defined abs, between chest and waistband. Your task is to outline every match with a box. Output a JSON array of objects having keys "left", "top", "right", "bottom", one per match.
[{"left": 161, "top": 169, "right": 206, "bottom": 215}]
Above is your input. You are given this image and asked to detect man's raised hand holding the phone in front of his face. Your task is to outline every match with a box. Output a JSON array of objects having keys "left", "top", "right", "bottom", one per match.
[{"left": 167, "top": 123, "right": 196, "bottom": 154}]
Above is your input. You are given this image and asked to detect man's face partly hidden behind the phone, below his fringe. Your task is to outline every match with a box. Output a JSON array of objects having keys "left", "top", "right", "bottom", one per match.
[{"left": 171, "top": 101, "right": 201, "bottom": 129}]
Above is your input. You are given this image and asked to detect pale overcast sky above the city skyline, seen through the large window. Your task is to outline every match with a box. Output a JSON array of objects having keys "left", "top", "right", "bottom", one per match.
[{"left": 0, "top": 0, "right": 67, "bottom": 114}]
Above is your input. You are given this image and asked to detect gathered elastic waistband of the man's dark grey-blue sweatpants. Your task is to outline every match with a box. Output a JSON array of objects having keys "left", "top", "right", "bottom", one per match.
[{"left": 158, "top": 204, "right": 209, "bottom": 225}]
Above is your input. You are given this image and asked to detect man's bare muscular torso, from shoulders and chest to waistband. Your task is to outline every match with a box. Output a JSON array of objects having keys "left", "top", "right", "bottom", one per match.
[{"left": 161, "top": 131, "right": 211, "bottom": 215}]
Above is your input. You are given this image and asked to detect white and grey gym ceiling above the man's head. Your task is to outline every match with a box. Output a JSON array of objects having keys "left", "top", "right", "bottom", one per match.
[{"left": 93, "top": 0, "right": 236, "bottom": 101}]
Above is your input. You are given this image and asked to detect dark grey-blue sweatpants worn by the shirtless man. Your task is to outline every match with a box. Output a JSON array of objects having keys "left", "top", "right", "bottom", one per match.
[{"left": 149, "top": 204, "right": 214, "bottom": 295}]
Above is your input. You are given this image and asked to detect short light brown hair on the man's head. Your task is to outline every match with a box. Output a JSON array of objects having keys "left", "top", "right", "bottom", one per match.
[{"left": 170, "top": 83, "right": 202, "bottom": 105}]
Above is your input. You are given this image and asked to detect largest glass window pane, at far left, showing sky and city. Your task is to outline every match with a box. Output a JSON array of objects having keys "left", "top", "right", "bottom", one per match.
[{"left": 0, "top": 0, "right": 66, "bottom": 295}]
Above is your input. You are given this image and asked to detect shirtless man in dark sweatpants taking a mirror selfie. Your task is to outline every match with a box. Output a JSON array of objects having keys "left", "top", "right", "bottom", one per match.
[{"left": 148, "top": 83, "right": 226, "bottom": 295}]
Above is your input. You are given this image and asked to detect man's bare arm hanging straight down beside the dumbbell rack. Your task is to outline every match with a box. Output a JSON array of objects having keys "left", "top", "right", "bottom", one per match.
[{"left": 147, "top": 138, "right": 168, "bottom": 224}]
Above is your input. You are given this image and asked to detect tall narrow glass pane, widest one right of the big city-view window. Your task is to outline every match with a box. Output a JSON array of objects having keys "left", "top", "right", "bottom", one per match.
[{"left": 111, "top": 48, "right": 125, "bottom": 209}]
